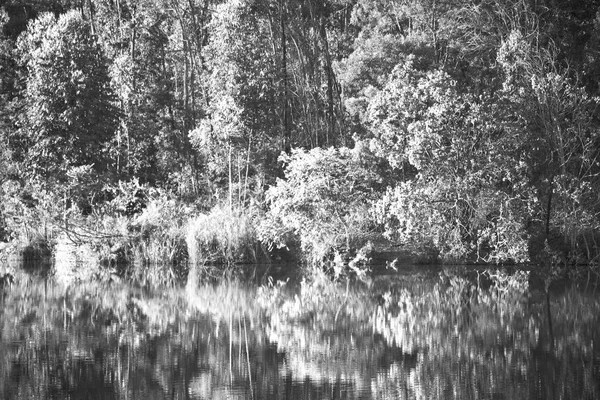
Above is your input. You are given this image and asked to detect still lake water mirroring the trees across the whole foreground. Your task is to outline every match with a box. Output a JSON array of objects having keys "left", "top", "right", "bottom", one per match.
[{"left": 0, "top": 266, "right": 600, "bottom": 400}]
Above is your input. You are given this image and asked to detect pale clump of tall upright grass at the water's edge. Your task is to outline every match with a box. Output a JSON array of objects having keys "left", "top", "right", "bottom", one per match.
[{"left": 185, "top": 206, "right": 265, "bottom": 265}]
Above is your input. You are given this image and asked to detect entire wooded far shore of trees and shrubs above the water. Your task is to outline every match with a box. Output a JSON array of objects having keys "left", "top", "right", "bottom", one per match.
[{"left": 0, "top": 0, "right": 600, "bottom": 281}]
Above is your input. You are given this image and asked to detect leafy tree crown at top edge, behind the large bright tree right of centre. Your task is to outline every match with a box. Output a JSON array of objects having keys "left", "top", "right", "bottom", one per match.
[{"left": 336, "top": 0, "right": 458, "bottom": 142}]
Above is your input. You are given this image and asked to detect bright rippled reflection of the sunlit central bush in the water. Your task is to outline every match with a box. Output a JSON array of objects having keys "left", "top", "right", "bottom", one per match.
[{"left": 257, "top": 277, "right": 386, "bottom": 391}]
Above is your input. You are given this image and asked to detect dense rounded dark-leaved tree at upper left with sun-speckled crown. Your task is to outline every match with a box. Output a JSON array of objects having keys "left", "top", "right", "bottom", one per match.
[{"left": 18, "top": 11, "right": 119, "bottom": 180}]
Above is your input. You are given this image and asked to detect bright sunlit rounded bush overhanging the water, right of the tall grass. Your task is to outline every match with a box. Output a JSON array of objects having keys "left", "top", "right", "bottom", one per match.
[{"left": 259, "top": 142, "right": 384, "bottom": 265}]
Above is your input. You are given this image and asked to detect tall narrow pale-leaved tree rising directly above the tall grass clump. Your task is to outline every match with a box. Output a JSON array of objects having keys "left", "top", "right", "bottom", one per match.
[{"left": 190, "top": 0, "right": 282, "bottom": 206}]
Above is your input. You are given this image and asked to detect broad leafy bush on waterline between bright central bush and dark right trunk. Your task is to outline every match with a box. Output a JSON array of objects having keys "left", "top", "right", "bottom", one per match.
[{"left": 373, "top": 177, "right": 529, "bottom": 263}]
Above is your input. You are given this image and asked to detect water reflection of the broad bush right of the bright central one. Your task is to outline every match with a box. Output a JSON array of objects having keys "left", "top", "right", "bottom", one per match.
[{"left": 375, "top": 270, "right": 529, "bottom": 349}]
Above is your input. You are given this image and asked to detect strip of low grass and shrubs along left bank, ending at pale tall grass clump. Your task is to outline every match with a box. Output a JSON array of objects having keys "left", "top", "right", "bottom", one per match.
[{"left": 0, "top": 186, "right": 268, "bottom": 286}]
